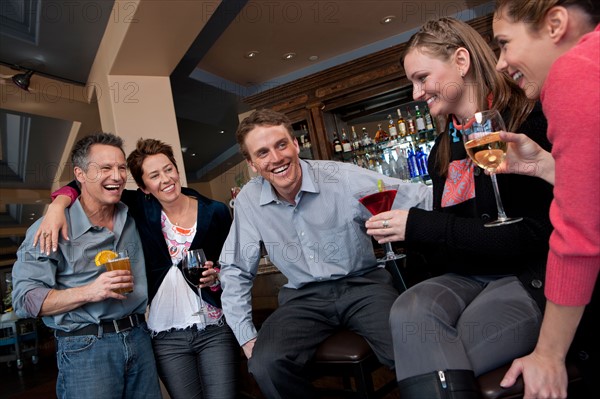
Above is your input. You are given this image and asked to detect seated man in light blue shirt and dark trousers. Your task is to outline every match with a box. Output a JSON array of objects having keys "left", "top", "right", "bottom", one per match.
[{"left": 220, "top": 110, "right": 432, "bottom": 399}]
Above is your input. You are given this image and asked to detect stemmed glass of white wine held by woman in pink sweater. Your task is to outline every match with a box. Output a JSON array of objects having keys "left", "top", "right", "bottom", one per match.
[{"left": 462, "top": 110, "right": 523, "bottom": 227}]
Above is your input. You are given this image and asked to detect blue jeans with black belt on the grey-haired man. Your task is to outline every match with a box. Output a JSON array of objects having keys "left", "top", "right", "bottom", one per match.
[{"left": 56, "top": 323, "right": 162, "bottom": 399}]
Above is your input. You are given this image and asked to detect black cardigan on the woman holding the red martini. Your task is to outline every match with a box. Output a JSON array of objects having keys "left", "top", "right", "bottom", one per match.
[{"left": 405, "top": 104, "right": 552, "bottom": 310}]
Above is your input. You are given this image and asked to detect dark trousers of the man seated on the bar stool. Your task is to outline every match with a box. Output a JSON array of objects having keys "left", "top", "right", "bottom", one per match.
[{"left": 248, "top": 269, "right": 398, "bottom": 399}]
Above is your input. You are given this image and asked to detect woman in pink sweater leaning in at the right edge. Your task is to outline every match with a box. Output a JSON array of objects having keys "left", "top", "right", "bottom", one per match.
[{"left": 493, "top": 0, "right": 600, "bottom": 398}]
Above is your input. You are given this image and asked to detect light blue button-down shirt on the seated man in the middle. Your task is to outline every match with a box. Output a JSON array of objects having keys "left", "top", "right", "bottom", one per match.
[{"left": 220, "top": 160, "right": 432, "bottom": 345}]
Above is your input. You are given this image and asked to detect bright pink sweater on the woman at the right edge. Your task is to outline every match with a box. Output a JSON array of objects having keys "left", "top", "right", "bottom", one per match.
[{"left": 540, "top": 25, "right": 600, "bottom": 306}]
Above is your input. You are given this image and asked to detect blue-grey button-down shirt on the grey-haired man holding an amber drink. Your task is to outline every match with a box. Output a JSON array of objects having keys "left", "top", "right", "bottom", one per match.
[{"left": 12, "top": 200, "right": 148, "bottom": 331}]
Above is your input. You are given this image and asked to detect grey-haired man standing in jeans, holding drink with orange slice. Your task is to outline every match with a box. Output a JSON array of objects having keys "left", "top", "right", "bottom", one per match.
[{"left": 12, "top": 133, "right": 161, "bottom": 399}]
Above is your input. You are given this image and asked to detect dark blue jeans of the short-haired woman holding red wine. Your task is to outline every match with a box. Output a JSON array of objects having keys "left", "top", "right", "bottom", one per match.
[{"left": 152, "top": 323, "right": 240, "bottom": 399}]
